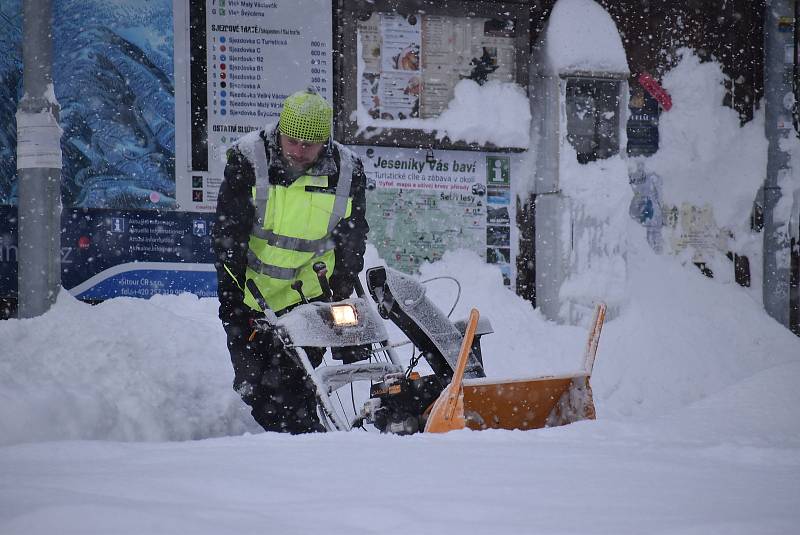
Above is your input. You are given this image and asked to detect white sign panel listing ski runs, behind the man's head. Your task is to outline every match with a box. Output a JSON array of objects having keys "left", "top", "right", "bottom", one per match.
[{"left": 176, "top": 0, "right": 333, "bottom": 212}]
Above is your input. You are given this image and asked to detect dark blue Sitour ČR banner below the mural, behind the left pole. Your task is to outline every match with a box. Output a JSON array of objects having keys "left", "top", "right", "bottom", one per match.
[{"left": 0, "top": 206, "right": 217, "bottom": 300}]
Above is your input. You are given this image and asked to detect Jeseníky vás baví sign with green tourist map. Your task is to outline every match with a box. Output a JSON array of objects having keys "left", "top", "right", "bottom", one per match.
[{"left": 351, "top": 146, "right": 519, "bottom": 284}]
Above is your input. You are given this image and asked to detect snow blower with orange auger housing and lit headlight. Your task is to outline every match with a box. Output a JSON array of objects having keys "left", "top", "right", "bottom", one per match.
[{"left": 248, "top": 264, "right": 605, "bottom": 434}]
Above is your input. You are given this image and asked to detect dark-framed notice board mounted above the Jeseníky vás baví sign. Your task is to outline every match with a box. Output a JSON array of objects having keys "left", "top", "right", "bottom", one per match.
[{"left": 336, "top": 0, "right": 529, "bottom": 150}]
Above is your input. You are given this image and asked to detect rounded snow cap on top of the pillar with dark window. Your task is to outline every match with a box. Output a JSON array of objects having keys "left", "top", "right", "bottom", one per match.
[{"left": 539, "top": 0, "right": 630, "bottom": 75}]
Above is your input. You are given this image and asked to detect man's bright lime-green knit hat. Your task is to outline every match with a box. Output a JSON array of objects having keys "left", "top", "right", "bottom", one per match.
[{"left": 278, "top": 91, "right": 333, "bottom": 143}]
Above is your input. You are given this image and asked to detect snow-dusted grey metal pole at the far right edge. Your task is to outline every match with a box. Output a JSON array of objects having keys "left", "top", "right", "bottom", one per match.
[{"left": 763, "top": 0, "right": 795, "bottom": 327}]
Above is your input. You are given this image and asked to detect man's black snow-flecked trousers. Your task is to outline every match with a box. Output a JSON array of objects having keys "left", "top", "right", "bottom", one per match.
[{"left": 226, "top": 326, "right": 325, "bottom": 434}]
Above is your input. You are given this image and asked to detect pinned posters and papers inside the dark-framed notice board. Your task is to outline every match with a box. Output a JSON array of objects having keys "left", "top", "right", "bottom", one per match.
[{"left": 357, "top": 13, "right": 516, "bottom": 123}]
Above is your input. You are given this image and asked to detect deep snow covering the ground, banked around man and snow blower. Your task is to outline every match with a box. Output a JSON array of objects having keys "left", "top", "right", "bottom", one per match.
[{"left": 0, "top": 238, "right": 800, "bottom": 535}]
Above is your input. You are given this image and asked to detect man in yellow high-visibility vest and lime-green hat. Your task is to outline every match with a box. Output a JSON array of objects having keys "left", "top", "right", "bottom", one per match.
[{"left": 213, "top": 91, "right": 369, "bottom": 433}]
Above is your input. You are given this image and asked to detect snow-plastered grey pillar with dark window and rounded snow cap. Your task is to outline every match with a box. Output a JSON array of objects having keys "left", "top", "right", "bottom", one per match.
[{"left": 531, "top": 0, "right": 630, "bottom": 324}]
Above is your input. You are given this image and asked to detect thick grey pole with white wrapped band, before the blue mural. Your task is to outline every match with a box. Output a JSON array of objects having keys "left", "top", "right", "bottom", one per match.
[{"left": 17, "top": 0, "right": 61, "bottom": 318}]
